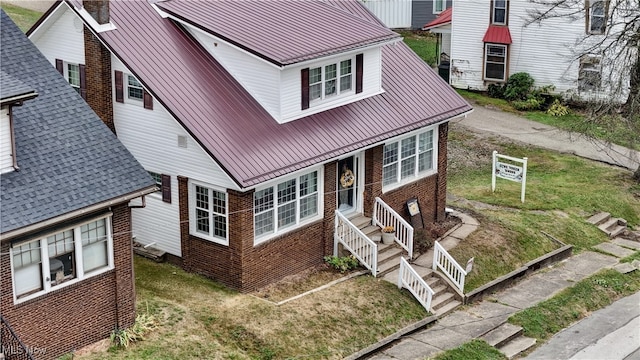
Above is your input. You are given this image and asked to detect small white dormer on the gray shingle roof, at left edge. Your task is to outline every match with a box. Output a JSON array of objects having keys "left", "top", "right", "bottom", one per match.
[{"left": 0, "top": 70, "right": 38, "bottom": 173}]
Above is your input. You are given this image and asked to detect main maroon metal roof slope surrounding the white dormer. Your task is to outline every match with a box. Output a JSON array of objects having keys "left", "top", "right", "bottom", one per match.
[{"left": 67, "top": 0, "right": 471, "bottom": 187}]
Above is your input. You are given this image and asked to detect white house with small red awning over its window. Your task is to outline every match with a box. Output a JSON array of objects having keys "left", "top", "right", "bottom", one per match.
[{"left": 424, "top": 0, "right": 628, "bottom": 98}]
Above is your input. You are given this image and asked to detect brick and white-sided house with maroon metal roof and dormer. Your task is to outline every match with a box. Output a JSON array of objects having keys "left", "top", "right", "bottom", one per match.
[{"left": 29, "top": 0, "right": 471, "bottom": 291}]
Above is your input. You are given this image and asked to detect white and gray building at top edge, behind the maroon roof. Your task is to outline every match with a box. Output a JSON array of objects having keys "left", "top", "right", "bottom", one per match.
[{"left": 360, "top": 0, "right": 452, "bottom": 30}]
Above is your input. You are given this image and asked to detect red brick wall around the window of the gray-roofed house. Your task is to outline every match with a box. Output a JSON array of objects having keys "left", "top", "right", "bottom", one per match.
[{"left": 0, "top": 204, "right": 135, "bottom": 359}]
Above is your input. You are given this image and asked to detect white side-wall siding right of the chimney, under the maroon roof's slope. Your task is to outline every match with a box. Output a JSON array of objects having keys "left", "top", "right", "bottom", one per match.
[{"left": 111, "top": 57, "right": 238, "bottom": 256}]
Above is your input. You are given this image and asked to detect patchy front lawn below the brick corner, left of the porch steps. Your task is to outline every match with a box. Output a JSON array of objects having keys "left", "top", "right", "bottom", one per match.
[{"left": 75, "top": 257, "right": 428, "bottom": 359}]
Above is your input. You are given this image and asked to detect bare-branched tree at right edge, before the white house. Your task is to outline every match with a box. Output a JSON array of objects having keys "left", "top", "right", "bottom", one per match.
[{"left": 527, "top": 0, "right": 640, "bottom": 182}]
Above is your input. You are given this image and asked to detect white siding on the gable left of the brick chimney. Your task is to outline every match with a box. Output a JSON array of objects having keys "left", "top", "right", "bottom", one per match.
[{"left": 31, "top": 6, "right": 85, "bottom": 66}]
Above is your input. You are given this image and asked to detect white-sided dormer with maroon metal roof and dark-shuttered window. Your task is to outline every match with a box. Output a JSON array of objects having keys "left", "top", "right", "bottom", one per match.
[{"left": 155, "top": 0, "right": 401, "bottom": 123}]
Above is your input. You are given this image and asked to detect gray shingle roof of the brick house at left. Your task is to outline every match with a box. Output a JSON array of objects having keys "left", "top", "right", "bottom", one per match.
[{"left": 0, "top": 11, "right": 155, "bottom": 233}]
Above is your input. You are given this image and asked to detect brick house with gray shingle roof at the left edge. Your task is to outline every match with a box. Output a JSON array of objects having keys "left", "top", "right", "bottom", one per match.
[{"left": 0, "top": 11, "right": 156, "bottom": 359}]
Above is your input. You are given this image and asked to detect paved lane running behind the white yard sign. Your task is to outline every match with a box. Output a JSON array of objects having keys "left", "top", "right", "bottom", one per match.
[{"left": 454, "top": 106, "right": 640, "bottom": 170}]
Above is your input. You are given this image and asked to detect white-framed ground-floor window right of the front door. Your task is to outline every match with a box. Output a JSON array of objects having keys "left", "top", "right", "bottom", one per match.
[{"left": 382, "top": 128, "right": 438, "bottom": 190}]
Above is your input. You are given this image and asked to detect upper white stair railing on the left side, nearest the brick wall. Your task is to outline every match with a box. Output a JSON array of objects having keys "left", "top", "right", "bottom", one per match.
[{"left": 333, "top": 210, "right": 378, "bottom": 277}]
